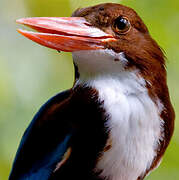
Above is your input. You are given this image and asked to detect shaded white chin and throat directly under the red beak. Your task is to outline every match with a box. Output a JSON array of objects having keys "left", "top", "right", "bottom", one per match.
[{"left": 72, "top": 49, "right": 128, "bottom": 78}]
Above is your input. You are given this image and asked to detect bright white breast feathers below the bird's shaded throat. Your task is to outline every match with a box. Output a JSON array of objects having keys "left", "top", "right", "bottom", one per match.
[{"left": 77, "top": 72, "right": 162, "bottom": 180}]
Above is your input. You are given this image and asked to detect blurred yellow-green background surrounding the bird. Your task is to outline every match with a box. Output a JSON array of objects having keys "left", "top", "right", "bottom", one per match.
[{"left": 0, "top": 0, "right": 179, "bottom": 180}]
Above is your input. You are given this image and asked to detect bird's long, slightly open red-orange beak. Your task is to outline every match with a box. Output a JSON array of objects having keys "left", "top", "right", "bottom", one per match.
[{"left": 16, "top": 17, "right": 115, "bottom": 52}]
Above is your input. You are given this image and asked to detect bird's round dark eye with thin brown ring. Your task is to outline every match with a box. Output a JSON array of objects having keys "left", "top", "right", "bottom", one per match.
[{"left": 113, "top": 16, "right": 131, "bottom": 34}]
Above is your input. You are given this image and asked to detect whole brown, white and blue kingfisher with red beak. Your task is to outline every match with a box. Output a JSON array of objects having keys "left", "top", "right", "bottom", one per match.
[{"left": 9, "top": 3, "right": 175, "bottom": 180}]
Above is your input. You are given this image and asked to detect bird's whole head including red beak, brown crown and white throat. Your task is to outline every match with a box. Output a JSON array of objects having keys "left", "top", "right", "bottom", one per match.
[{"left": 17, "top": 3, "right": 165, "bottom": 91}]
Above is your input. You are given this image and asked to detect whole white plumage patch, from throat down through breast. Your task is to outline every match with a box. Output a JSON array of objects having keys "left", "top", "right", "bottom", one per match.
[{"left": 73, "top": 49, "right": 163, "bottom": 180}]
